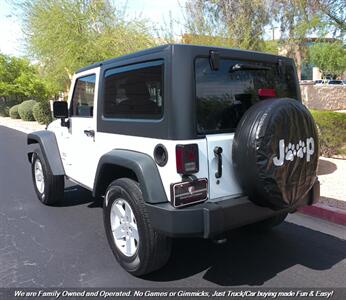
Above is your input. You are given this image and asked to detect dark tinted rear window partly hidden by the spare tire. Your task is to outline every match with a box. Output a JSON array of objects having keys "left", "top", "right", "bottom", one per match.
[{"left": 195, "top": 58, "right": 297, "bottom": 134}]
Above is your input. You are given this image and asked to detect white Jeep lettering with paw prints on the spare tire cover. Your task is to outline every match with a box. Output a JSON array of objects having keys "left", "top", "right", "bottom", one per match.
[{"left": 273, "top": 137, "right": 315, "bottom": 167}]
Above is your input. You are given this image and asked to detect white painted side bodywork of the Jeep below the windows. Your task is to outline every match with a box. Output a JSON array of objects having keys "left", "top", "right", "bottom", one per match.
[{"left": 49, "top": 121, "right": 208, "bottom": 200}]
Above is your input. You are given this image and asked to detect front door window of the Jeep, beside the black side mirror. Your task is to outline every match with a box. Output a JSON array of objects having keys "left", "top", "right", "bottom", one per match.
[{"left": 71, "top": 74, "right": 96, "bottom": 117}]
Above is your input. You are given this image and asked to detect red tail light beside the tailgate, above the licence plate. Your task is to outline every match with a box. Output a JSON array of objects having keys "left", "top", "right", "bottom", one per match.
[{"left": 175, "top": 144, "right": 199, "bottom": 175}]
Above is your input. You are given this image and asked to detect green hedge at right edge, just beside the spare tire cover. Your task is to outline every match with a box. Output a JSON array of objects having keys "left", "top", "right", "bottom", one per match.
[{"left": 311, "top": 110, "right": 346, "bottom": 157}]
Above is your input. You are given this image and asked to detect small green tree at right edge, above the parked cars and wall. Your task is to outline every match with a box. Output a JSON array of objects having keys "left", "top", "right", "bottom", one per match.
[{"left": 310, "top": 42, "right": 346, "bottom": 76}]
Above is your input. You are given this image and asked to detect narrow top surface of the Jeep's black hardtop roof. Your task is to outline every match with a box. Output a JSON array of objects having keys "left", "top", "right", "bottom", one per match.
[{"left": 76, "top": 44, "right": 291, "bottom": 73}]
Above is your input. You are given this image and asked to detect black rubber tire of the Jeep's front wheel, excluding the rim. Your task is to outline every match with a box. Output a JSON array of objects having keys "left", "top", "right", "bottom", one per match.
[{"left": 31, "top": 152, "right": 65, "bottom": 205}]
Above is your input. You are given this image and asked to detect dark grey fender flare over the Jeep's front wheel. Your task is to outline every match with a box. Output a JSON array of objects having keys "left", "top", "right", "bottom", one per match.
[{"left": 27, "top": 130, "right": 65, "bottom": 176}]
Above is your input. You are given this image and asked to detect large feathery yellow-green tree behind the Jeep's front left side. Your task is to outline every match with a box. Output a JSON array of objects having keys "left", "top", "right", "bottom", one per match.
[{"left": 20, "top": 0, "right": 155, "bottom": 92}]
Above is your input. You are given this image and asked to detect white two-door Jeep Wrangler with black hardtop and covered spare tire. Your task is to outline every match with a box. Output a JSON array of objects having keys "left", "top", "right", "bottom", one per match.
[{"left": 28, "top": 45, "right": 319, "bottom": 276}]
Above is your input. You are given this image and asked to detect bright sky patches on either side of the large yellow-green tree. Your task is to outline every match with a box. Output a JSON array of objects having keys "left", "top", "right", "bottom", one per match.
[{"left": 0, "top": 0, "right": 186, "bottom": 56}]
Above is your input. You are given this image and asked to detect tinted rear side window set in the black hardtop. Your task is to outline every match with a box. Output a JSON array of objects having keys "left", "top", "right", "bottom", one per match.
[{"left": 103, "top": 62, "right": 163, "bottom": 119}]
